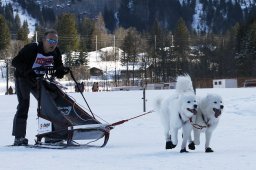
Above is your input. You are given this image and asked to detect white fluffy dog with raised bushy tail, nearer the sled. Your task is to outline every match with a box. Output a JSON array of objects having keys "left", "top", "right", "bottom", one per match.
[{"left": 157, "top": 75, "right": 197, "bottom": 153}]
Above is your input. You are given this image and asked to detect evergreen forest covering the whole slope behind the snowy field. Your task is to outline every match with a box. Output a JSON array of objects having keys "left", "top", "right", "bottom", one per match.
[{"left": 0, "top": 0, "right": 256, "bottom": 85}]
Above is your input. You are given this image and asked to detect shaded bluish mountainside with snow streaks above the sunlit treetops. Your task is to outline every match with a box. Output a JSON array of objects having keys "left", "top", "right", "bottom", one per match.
[{"left": 34, "top": 0, "right": 255, "bottom": 33}]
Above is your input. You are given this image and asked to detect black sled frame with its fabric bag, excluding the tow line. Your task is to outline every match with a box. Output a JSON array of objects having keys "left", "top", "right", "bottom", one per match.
[{"left": 35, "top": 68, "right": 113, "bottom": 147}]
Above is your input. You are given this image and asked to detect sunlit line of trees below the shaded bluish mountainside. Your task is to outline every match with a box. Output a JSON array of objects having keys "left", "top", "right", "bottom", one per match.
[{"left": 0, "top": 3, "right": 256, "bottom": 82}]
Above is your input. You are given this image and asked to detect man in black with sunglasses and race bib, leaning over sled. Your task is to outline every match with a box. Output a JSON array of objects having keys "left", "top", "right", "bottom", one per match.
[{"left": 12, "top": 30, "right": 68, "bottom": 146}]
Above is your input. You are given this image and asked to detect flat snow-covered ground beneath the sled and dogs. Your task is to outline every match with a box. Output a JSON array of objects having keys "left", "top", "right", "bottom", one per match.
[{"left": 0, "top": 88, "right": 256, "bottom": 170}]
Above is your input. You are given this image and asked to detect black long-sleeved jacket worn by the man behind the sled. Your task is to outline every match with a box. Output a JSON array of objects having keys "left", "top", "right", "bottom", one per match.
[{"left": 12, "top": 42, "right": 63, "bottom": 79}]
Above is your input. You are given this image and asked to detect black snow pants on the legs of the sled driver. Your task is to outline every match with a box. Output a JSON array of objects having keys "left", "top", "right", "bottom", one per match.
[{"left": 12, "top": 77, "right": 37, "bottom": 138}]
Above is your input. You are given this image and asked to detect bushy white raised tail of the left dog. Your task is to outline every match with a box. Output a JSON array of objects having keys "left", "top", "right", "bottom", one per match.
[{"left": 176, "top": 74, "right": 194, "bottom": 93}]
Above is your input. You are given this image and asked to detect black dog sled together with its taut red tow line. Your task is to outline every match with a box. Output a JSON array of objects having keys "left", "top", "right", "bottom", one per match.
[{"left": 30, "top": 67, "right": 154, "bottom": 149}]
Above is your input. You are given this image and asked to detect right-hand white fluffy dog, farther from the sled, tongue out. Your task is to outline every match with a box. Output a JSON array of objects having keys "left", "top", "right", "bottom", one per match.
[{"left": 189, "top": 94, "right": 224, "bottom": 152}]
